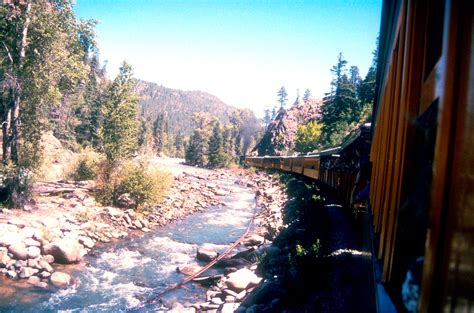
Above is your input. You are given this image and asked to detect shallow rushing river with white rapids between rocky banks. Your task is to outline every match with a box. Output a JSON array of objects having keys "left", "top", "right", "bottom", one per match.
[{"left": 0, "top": 162, "right": 256, "bottom": 313}]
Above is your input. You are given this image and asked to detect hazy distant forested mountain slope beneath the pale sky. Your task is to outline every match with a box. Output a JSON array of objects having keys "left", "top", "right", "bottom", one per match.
[{"left": 134, "top": 80, "right": 238, "bottom": 136}]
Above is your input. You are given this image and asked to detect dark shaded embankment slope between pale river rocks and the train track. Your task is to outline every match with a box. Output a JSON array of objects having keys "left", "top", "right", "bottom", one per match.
[{"left": 254, "top": 172, "right": 329, "bottom": 311}]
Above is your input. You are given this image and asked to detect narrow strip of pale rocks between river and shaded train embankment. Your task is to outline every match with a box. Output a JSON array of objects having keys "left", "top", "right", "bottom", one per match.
[{"left": 171, "top": 172, "right": 287, "bottom": 312}]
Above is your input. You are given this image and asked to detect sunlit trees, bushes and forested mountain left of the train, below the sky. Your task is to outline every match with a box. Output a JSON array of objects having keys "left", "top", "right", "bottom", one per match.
[{"left": 0, "top": 0, "right": 261, "bottom": 208}]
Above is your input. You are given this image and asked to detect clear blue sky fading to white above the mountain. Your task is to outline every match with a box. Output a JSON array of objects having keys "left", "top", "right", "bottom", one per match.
[{"left": 75, "top": 0, "right": 381, "bottom": 116}]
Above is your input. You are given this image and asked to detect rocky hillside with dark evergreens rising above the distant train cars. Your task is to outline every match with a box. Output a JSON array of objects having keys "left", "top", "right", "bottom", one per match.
[{"left": 254, "top": 50, "right": 377, "bottom": 156}]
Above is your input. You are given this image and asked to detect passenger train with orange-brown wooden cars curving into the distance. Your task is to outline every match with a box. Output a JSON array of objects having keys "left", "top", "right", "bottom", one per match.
[{"left": 244, "top": 0, "right": 474, "bottom": 312}]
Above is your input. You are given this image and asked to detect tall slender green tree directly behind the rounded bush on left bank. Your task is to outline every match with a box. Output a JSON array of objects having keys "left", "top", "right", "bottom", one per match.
[{"left": 101, "top": 62, "right": 138, "bottom": 167}]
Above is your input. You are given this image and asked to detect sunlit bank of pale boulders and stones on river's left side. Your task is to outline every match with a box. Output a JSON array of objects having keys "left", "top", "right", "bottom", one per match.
[{"left": 0, "top": 171, "right": 248, "bottom": 288}]
